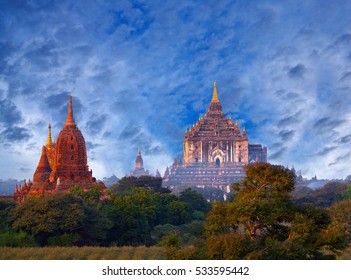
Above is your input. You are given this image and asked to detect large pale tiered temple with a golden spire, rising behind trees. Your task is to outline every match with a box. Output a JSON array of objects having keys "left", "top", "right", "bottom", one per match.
[{"left": 164, "top": 83, "right": 267, "bottom": 192}]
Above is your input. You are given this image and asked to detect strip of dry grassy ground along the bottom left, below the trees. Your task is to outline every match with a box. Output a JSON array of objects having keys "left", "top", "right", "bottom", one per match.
[{"left": 0, "top": 246, "right": 166, "bottom": 260}]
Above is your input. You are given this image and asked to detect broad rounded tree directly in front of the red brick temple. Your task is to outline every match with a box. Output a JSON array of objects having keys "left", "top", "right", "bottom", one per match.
[{"left": 12, "top": 193, "right": 112, "bottom": 245}]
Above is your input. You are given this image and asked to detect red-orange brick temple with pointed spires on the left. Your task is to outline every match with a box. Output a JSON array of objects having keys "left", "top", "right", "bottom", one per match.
[{"left": 14, "top": 96, "right": 104, "bottom": 202}]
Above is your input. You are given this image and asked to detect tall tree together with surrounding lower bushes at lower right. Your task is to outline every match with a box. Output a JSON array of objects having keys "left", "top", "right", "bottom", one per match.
[{"left": 206, "top": 163, "right": 345, "bottom": 259}]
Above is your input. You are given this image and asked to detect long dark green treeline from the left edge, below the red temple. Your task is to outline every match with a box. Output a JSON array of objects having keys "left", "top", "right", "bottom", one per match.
[{"left": 0, "top": 179, "right": 210, "bottom": 247}]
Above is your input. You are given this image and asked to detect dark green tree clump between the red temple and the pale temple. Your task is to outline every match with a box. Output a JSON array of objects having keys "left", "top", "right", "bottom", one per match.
[{"left": 103, "top": 188, "right": 201, "bottom": 245}]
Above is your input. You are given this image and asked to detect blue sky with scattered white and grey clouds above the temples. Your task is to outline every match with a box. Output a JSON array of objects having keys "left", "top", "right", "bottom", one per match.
[{"left": 0, "top": 0, "right": 351, "bottom": 179}]
